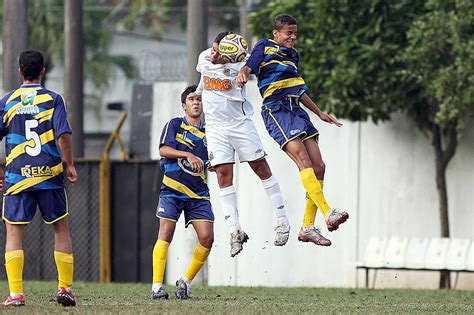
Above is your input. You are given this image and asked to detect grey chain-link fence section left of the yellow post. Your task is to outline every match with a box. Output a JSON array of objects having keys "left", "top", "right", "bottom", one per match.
[{"left": 0, "top": 161, "right": 100, "bottom": 281}]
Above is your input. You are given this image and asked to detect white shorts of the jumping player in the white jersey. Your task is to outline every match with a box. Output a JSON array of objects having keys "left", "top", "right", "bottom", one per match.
[{"left": 206, "top": 119, "right": 265, "bottom": 166}]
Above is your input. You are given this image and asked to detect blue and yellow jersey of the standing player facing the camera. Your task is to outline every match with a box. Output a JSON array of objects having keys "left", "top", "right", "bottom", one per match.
[{"left": 160, "top": 117, "right": 209, "bottom": 200}]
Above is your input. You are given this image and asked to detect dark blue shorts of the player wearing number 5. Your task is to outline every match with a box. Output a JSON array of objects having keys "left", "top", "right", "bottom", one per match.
[{"left": 2, "top": 189, "right": 69, "bottom": 224}]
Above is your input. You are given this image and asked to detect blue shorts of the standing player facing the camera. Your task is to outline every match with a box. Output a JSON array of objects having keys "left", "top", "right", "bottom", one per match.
[{"left": 156, "top": 197, "right": 214, "bottom": 227}]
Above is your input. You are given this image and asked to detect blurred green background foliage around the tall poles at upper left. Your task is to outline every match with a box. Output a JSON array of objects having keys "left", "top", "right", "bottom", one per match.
[{"left": 0, "top": 0, "right": 137, "bottom": 105}]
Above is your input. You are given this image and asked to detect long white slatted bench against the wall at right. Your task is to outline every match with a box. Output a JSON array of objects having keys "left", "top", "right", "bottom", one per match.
[{"left": 357, "top": 237, "right": 474, "bottom": 288}]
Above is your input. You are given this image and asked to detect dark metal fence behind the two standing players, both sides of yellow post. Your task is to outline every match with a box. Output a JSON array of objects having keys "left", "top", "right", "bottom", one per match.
[{"left": 0, "top": 160, "right": 162, "bottom": 282}]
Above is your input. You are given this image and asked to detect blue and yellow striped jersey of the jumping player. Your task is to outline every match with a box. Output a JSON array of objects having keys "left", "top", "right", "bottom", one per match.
[{"left": 245, "top": 39, "right": 308, "bottom": 105}]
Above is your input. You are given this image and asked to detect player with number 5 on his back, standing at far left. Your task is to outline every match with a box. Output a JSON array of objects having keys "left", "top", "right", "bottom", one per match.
[{"left": 0, "top": 50, "right": 77, "bottom": 306}]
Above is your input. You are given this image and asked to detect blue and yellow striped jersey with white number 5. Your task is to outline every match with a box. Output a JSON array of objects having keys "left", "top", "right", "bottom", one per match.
[{"left": 0, "top": 84, "right": 72, "bottom": 195}]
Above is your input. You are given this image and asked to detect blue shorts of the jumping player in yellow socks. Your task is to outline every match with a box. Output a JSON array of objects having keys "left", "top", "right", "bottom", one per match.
[{"left": 262, "top": 99, "right": 319, "bottom": 149}]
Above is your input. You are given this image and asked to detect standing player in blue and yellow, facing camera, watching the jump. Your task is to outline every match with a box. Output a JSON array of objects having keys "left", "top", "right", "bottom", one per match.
[{"left": 151, "top": 85, "right": 214, "bottom": 300}]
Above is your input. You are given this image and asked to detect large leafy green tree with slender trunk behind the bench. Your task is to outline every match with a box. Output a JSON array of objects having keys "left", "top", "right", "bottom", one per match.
[{"left": 252, "top": 0, "right": 474, "bottom": 287}]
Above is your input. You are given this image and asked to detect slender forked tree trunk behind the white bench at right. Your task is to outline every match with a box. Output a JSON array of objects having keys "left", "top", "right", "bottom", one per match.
[{"left": 431, "top": 124, "right": 457, "bottom": 288}]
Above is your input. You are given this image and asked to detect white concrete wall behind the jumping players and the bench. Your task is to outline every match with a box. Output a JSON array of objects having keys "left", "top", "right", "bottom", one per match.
[{"left": 151, "top": 81, "right": 474, "bottom": 289}]
